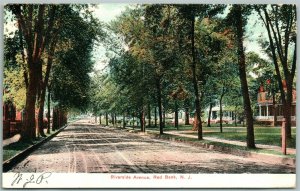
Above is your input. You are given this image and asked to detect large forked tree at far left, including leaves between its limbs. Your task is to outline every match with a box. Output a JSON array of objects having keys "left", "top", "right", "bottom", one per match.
[{"left": 7, "top": 4, "right": 56, "bottom": 142}]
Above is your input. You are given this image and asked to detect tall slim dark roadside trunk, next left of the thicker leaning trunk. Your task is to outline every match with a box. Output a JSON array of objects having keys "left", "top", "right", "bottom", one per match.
[{"left": 190, "top": 13, "right": 203, "bottom": 140}]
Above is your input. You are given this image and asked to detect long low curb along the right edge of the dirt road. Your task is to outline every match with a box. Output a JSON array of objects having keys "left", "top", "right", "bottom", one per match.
[{"left": 123, "top": 129, "right": 296, "bottom": 166}]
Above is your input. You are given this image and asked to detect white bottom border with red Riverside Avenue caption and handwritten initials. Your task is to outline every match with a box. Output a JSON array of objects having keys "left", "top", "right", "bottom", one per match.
[{"left": 3, "top": 173, "right": 296, "bottom": 188}]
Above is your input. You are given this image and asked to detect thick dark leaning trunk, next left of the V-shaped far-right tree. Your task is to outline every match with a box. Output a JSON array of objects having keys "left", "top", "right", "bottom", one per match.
[{"left": 233, "top": 5, "right": 255, "bottom": 148}]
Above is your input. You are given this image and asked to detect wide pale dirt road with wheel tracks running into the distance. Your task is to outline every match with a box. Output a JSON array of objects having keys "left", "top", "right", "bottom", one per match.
[{"left": 10, "top": 120, "right": 296, "bottom": 173}]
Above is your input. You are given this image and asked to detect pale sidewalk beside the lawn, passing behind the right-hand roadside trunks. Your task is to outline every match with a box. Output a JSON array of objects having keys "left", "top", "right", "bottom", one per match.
[{"left": 164, "top": 130, "right": 296, "bottom": 154}]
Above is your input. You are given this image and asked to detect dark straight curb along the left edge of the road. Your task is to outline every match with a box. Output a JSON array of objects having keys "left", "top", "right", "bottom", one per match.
[{"left": 2, "top": 124, "right": 69, "bottom": 172}]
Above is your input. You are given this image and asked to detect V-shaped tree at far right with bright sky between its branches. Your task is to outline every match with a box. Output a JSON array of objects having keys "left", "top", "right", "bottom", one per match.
[{"left": 255, "top": 5, "right": 297, "bottom": 139}]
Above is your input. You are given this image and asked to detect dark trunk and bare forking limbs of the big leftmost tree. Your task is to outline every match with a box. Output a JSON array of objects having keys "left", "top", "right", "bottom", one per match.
[{"left": 11, "top": 5, "right": 48, "bottom": 142}]
